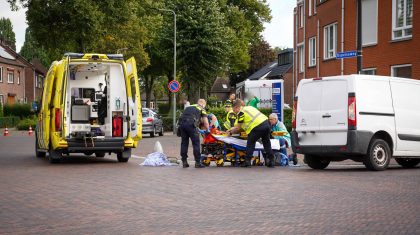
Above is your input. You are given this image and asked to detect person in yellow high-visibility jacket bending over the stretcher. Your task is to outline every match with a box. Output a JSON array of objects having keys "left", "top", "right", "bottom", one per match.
[{"left": 227, "top": 100, "right": 274, "bottom": 167}]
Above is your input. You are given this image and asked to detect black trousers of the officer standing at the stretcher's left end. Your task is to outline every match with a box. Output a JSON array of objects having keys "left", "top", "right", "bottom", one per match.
[{"left": 180, "top": 121, "right": 201, "bottom": 162}]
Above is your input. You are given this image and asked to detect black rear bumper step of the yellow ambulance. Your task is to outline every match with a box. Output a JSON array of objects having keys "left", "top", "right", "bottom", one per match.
[{"left": 66, "top": 137, "right": 124, "bottom": 152}]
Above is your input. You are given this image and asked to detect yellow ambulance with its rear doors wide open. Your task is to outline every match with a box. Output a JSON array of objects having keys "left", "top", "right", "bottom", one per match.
[{"left": 35, "top": 53, "right": 142, "bottom": 163}]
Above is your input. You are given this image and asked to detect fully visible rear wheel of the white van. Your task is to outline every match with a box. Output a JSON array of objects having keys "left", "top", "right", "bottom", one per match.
[{"left": 363, "top": 139, "right": 391, "bottom": 171}]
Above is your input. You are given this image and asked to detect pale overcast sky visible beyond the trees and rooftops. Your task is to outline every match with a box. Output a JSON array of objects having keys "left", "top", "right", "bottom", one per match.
[{"left": 0, "top": 0, "right": 296, "bottom": 52}]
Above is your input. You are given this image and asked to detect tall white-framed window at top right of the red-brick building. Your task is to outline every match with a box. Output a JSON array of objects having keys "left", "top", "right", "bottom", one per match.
[{"left": 392, "top": 0, "right": 413, "bottom": 39}]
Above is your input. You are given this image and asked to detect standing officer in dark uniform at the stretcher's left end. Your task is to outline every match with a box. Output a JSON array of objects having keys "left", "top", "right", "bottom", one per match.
[{"left": 179, "top": 99, "right": 209, "bottom": 168}]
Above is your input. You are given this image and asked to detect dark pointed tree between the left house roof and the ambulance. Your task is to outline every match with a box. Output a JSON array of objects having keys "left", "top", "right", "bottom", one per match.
[{"left": 19, "top": 27, "right": 51, "bottom": 68}]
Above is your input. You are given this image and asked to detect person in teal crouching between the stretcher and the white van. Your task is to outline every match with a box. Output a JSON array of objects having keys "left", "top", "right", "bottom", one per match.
[{"left": 268, "top": 113, "right": 298, "bottom": 166}]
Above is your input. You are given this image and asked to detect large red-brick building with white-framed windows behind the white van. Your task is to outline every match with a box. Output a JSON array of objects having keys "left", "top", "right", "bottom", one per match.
[{"left": 293, "top": 0, "right": 420, "bottom": 95}]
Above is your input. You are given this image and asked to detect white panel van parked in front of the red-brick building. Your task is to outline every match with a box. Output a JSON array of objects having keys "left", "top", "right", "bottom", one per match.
[{"left": 292, "top": 75, "right": 420, "bottom": 170}]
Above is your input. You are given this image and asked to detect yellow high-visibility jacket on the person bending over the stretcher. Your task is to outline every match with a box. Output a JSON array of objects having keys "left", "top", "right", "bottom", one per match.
[{"left": 238, "top": 106, "right": 268, "bottom": 135}]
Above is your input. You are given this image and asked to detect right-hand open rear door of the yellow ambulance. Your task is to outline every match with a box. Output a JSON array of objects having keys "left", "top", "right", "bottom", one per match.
[{"left": 126, "top": 57, "right": 142, "bottom": 140}]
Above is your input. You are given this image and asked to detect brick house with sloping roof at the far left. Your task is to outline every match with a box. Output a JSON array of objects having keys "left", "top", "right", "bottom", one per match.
[{"left": 0, "top": 43, "right": 47, "bottom": 104}]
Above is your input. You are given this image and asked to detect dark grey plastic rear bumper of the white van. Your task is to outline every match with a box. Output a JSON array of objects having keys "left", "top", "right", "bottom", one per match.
[{"left": 291, "top": 130, "right": 373, "bottom": 156}]
